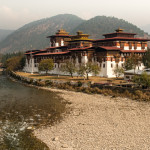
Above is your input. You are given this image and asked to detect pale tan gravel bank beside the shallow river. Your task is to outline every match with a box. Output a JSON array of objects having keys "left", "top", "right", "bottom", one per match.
[{"left": 34, "top": 89, "right": 150, "bottom": 150}]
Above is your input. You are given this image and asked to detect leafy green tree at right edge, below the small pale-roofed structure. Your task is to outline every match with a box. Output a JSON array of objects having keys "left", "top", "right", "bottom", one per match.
[{"left": 133, "top": 72, "right": 150, "bottom": 88}]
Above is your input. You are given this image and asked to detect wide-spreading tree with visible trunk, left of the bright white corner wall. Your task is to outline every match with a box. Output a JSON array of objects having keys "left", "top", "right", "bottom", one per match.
[{"left": 78, "top": 62, "right": 100, "bottom": 80}]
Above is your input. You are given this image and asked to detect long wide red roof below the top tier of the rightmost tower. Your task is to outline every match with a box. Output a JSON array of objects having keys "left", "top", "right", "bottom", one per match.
[{"left": 93, "top": 37, "right": 150, "bottom": 42}]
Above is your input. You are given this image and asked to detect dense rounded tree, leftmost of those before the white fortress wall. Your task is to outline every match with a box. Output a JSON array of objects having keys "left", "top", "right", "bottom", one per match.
[{"left": 39, "top": 59, "right": 54, "bottom": 75}]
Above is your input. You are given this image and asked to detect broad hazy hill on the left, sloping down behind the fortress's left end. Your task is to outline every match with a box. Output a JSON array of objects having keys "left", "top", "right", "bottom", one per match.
[{"left": 0, "top": 14, "right": 84, "bottom": 53}]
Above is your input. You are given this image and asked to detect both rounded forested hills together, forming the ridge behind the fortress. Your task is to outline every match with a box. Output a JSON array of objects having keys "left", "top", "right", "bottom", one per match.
[{"left": 0, "top": 14, "right": 148, "bottom": 53}]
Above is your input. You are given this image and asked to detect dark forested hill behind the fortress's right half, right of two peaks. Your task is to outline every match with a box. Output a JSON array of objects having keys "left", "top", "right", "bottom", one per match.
[{"left": 72, "top": 16, "right": 147, "bottom": 39}]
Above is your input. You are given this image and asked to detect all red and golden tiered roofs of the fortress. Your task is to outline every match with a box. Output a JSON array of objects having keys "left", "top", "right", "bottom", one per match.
[{"left": 25, "top": 28, "right": 150, "bottom": 56}]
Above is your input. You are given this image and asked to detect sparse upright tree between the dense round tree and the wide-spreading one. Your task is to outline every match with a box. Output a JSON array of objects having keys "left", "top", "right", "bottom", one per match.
[{"left": 61, "top": 61, "right": 77, "bottom": 78}]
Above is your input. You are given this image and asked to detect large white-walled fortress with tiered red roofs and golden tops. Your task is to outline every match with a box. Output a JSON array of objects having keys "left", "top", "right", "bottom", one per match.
[{"left": 24, "top": 28, "right": 149, "bottom": 77}]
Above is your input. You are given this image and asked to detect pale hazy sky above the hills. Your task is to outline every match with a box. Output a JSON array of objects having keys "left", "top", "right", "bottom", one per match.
[{"left": 0, "top": 0, "right": 150, "bottom": 29}]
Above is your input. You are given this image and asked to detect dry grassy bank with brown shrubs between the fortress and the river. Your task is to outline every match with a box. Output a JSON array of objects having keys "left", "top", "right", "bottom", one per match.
[{"left": 9, "top": 72, "right": 150, "bottom": 101}]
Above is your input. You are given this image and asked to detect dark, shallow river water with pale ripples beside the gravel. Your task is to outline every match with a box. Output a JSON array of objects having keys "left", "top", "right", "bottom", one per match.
[{"left": 0, "top": 75, "right": 66, "bottom": 150}]
